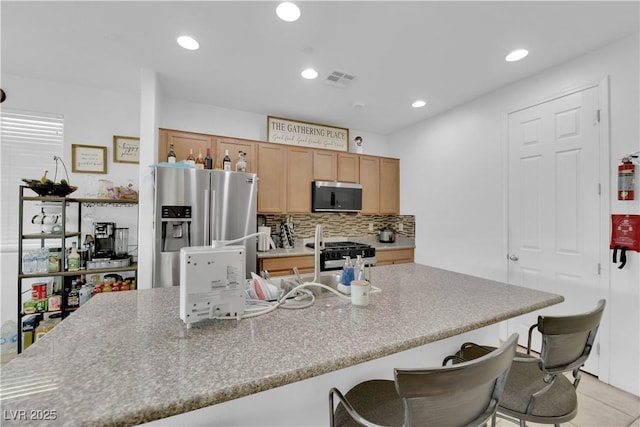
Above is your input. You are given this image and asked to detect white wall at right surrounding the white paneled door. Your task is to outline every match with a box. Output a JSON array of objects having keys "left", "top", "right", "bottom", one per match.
[{"left": 389, "top": 34, "right": 640, "bottom": 395}]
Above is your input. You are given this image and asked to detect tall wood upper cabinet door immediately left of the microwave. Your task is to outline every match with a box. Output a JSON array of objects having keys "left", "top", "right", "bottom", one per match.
[{"left": 287, "top": 147, "right": 314, "bottom": 213}]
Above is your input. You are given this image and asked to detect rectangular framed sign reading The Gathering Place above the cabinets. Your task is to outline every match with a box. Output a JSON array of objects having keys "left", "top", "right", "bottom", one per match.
[{"left": 267, "top": 116, "right": 349, "bottom": 151}]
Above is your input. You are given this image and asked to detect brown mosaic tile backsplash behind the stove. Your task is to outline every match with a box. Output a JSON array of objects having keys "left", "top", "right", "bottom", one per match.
[{"left": 258, "top": 213, "right": 416, "bottom": 244}]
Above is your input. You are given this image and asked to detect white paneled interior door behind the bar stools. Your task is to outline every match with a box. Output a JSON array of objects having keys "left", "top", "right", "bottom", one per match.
[{"left": 508, "top": 87, "right": 604, "bottom": 375}]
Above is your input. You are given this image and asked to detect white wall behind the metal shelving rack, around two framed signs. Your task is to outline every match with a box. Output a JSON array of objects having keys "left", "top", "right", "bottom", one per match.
[{"left": 0, "top": 74, "right": 140, "bottom": 328}]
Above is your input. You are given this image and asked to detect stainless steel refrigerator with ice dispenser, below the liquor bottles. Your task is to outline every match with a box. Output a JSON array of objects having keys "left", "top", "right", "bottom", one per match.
[{"left": 153, "top": 166, "right": 258, "bottom": 287}]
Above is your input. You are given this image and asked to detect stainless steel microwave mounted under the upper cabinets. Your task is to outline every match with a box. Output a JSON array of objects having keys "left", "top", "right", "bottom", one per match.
[{"left": 311, "top": 181, "right": 362, "bottom": 212}]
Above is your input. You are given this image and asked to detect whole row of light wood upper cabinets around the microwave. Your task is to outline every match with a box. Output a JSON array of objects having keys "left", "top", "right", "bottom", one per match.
[{"left": 158, "top": 129, "right": 400, "bottom": 215}]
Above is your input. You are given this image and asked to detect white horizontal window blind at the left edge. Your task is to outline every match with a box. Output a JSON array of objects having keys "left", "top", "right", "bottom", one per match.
[{"left": 0, "top": 108, "right": 64, "bottom": 252}]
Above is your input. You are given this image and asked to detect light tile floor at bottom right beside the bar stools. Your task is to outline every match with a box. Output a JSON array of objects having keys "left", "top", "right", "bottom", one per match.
[{"left": 496, "top": 373, "right": 640, "bottom": 427}]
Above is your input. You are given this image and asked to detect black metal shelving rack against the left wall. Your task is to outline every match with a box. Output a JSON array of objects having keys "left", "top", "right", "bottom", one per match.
[{"left": 17, "top": 185, "right": 138, "bottom": 354}]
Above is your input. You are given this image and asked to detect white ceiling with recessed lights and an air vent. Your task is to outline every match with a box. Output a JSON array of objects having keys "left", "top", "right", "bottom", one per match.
[{"left": 0, "top": 0, "right": 640, "bottom": 134}]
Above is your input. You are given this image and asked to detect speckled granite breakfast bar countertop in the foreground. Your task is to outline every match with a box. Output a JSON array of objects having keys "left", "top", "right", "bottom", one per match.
[{"left": 0, "top": 264, "right": 563, "bottom": 426}]
